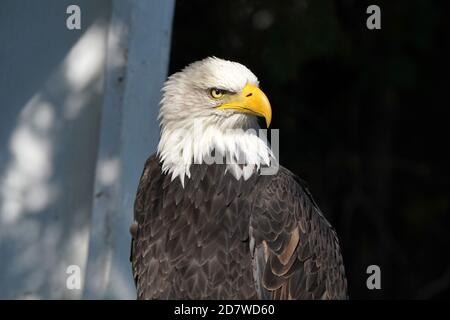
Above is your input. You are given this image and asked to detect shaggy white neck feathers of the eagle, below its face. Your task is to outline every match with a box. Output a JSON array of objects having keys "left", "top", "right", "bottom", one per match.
[{"left": 158, "top": 122, "right": 273, "bottom": 186}]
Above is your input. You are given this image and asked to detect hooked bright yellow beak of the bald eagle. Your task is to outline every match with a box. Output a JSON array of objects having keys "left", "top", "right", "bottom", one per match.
[{"left": 217, "top": 84, "right": 272, "bottom": 127}]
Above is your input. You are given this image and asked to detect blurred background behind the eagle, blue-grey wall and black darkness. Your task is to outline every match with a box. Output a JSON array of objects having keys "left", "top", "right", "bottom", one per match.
[{"left": 0, "top": 0, "right": 450, "bottom": 299}]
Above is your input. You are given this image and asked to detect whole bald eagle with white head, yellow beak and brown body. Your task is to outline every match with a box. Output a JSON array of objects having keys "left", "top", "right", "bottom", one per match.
[{"left": 130, "top": 57, "right": 347, "bottom": 299}]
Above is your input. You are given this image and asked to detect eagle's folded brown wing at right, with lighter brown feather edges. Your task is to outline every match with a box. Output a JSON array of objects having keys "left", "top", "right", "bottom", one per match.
[{"left": 250, "top": 167, "right": 348, "bottom": 300}]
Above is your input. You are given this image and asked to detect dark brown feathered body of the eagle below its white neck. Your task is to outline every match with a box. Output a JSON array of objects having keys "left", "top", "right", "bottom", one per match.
[{"left": 130, "top": 155, "right": 347, "bottom": 299}]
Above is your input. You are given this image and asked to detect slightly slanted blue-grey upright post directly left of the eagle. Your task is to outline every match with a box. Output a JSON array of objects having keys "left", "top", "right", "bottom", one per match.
[{"left": 83, "top": 0, "right": 174, "bottom": 299}]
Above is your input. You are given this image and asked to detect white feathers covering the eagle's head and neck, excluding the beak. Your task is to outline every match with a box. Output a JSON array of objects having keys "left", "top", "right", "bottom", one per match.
[{"left": 158, "top": 57, "right": 273, "bottom": 185}]
